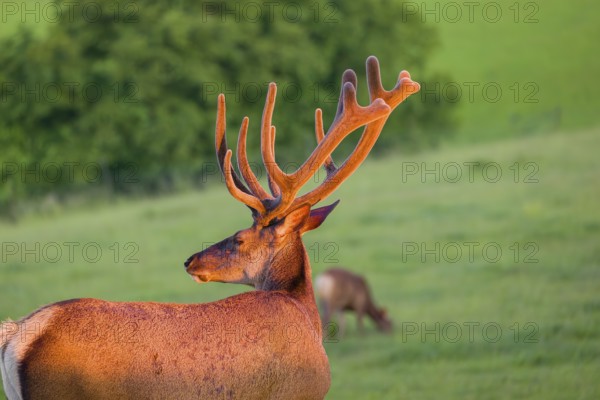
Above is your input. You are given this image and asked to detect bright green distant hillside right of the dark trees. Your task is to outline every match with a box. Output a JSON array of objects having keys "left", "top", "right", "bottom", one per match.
[{"left": 424, "top": 0, "right": 600, "bottom": 141}]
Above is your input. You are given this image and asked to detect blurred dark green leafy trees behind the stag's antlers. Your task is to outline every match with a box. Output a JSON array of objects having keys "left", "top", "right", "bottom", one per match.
[{"left": 0, "top": 0, "right": 453, "bottom": 220}]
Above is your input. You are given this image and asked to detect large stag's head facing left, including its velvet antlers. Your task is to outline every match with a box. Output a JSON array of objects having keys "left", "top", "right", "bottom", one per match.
[{"left": 184, "top": 56, "right": 419, "bottom": 290}]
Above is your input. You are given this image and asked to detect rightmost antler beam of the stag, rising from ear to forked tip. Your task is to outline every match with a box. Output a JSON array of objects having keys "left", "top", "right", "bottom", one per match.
[{"left": 290, "top": 56, "right": 420, "bottom": 209}]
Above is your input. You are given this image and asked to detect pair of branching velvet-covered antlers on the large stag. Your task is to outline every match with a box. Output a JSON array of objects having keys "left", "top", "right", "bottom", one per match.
[{"left": 216, "top": 56, "right": 420, "bottom": 225}]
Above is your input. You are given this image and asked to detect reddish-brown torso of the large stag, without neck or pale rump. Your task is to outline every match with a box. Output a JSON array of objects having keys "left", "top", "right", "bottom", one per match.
[{"left": 11, "top": 291, "right": 329, "bottom": 400}]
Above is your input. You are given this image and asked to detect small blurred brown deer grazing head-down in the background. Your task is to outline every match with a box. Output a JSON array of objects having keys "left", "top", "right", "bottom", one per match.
[{"left": 315, "top": 268, "right": 392, "bottom": 336}]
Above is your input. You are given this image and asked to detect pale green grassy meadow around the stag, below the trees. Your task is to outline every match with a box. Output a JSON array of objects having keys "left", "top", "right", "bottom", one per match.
[{"left": 0, "top": 131, "right": 600, "bottom": 400}]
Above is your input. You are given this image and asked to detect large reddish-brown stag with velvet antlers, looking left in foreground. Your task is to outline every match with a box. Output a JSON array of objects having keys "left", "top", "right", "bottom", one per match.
[{"left": 0, "top": 57, "right": 419, "bottom": 400}]
